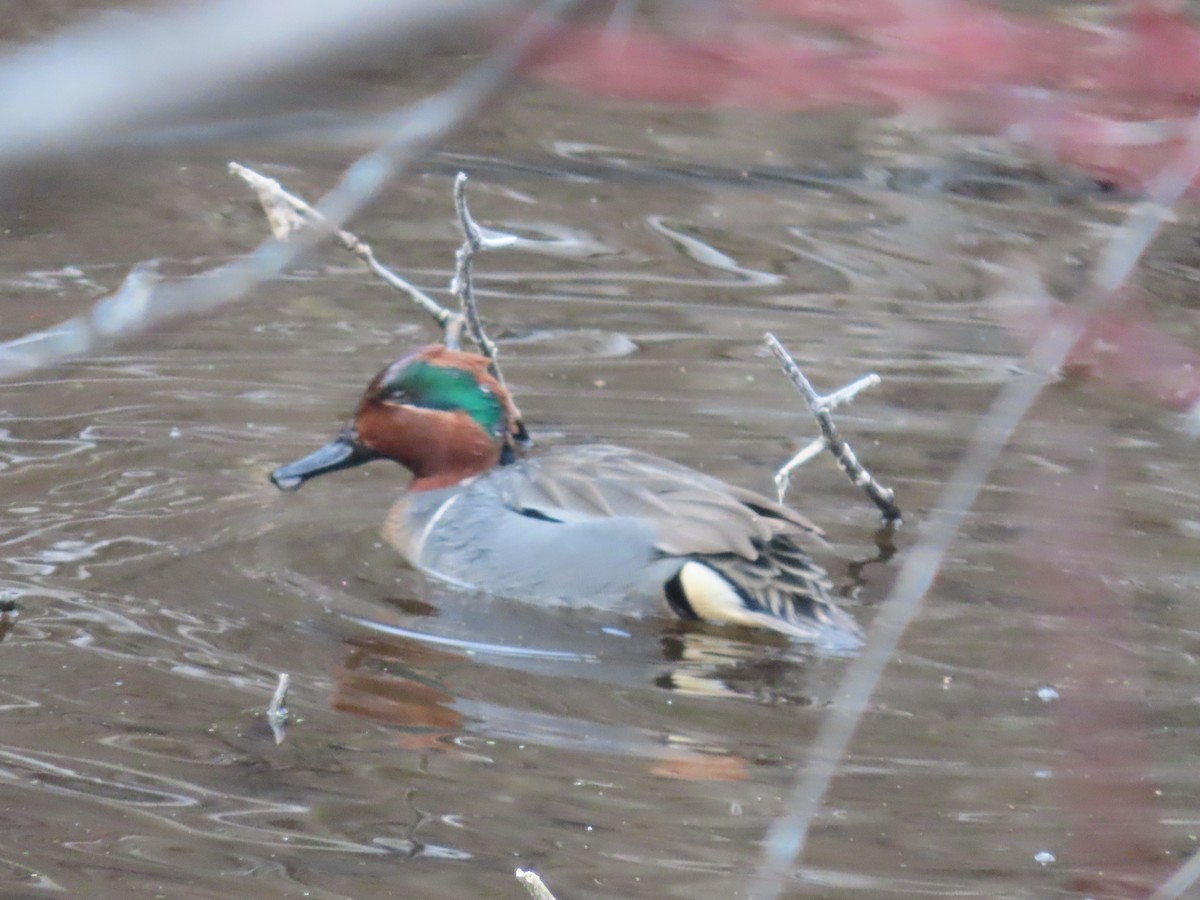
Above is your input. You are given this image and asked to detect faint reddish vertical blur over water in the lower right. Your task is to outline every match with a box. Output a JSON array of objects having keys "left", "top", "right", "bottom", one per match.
[{"left": 1020, "top": 460, "right": 1171, "bottom": 898}]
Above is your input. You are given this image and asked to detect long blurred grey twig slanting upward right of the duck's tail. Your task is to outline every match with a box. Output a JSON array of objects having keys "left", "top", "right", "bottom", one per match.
[{"left": 748, "top": 102, "right": 1200, "bottom": 900}]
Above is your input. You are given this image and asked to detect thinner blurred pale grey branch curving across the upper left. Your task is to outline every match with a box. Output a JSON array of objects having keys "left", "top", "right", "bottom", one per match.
[{"left": 0, "top": 0, "right": 577, "bottom": 378}]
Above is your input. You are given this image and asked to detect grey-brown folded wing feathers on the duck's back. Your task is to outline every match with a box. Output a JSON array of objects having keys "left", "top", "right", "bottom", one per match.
[{"left": 496, "top": 445, "right": 821, "bottom": 559}]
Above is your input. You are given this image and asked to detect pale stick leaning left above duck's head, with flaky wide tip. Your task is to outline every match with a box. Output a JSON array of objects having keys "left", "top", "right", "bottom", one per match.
[{"left": 229, "top": 162, "right": 466, "bottom": 349}]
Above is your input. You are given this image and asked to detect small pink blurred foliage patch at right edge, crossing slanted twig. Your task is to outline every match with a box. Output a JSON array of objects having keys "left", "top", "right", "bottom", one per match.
[{"left": 988, "top": 288, "right": 1200, "bottom": 413}]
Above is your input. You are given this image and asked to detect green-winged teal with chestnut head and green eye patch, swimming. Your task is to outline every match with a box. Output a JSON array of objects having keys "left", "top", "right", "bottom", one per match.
[{"left": 270, "top": 344, "right": 863, "bottom": 648}]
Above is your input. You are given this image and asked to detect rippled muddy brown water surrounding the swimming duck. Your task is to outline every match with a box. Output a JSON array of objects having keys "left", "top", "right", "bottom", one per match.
[{"left": 0, "top": 8, "right": 1200, "bottom": 900}]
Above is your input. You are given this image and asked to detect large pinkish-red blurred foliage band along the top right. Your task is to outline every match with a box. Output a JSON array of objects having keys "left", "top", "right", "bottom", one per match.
[{"left": 528, "top": 0, "right": 1200, "bottom": 192}]
